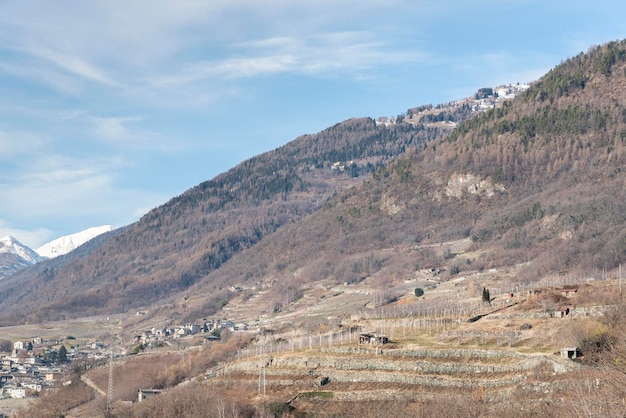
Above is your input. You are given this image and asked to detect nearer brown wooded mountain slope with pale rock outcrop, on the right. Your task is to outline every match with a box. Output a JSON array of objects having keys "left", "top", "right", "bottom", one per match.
[{"left": 185, "top": 42, "right": 626, "bottom": 312}]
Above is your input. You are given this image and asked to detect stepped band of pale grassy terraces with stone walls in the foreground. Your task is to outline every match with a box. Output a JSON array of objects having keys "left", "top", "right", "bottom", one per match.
[{"left": 208, "top": 348, "right": 580, "bottom": 401}]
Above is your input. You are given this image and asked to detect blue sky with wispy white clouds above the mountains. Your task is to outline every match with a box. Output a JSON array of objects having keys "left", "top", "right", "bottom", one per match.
[{"left": 0, "top": 0, "right": 626, "bottom": 248}]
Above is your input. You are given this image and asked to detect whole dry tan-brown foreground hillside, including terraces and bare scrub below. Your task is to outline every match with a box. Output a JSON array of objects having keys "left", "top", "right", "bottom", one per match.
[{"left": 19, "top": 280, "right": 626, "bottom": 418}]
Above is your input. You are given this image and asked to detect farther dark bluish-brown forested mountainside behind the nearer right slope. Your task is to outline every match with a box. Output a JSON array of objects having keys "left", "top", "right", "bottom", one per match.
[{"left": 0, "top": 107, "right": 471, "bottom": 323}]
